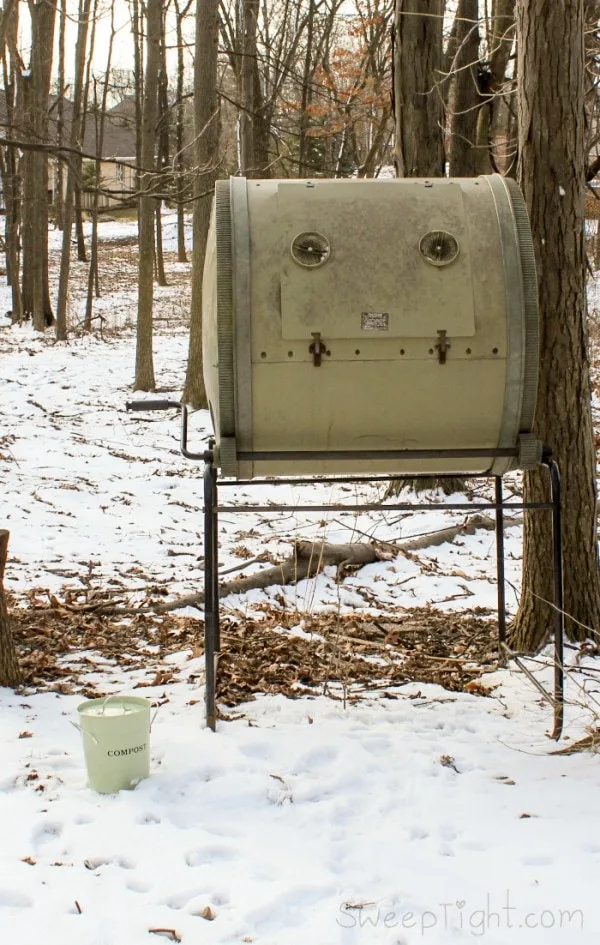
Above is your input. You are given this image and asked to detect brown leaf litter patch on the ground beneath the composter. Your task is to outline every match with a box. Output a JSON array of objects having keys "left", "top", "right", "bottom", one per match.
[{"left": 11, "top": 591, "right": 497, "bottom": 708}]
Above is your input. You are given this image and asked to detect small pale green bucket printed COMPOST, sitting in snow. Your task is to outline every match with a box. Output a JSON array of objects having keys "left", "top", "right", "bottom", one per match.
[{"left": 77, "top": 696, "right": 151, "bottom": 794}]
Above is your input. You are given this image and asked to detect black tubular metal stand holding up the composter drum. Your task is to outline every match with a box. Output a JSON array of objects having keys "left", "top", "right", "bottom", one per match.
[{"left": 204, "top": 448, "right": 564, "bottom": 739}]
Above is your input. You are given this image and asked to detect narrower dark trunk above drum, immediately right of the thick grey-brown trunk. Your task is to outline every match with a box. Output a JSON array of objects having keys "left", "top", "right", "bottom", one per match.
[{"left": 450, "top": 0, "right": 481, "bottom": 177}]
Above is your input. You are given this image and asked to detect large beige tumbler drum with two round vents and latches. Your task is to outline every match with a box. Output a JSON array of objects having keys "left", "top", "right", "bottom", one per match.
[{"left": 202, "top": 175, "right": 540, "bottom": 479}]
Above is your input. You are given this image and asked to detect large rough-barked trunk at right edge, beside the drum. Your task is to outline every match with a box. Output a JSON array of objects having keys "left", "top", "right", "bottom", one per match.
[{"left": 513, "top": 0, "right": 600, "bottom": 651}]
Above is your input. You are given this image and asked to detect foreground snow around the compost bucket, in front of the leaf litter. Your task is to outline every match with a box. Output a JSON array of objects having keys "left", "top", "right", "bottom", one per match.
[{"left": 0, "top": 664, "right": 600, "bottom": 945}]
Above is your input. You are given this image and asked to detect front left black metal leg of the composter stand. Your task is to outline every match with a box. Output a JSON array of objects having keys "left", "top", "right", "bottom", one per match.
[{"left": 204, "top": 458, "right": 219, "bottom": 732}]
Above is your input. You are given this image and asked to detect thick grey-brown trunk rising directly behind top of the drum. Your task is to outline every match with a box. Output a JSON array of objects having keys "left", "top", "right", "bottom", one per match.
[{"left": 394, "top": 0, "right": 444, "bottom": 177}]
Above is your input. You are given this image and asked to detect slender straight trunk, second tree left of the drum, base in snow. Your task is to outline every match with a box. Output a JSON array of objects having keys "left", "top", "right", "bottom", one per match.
[{"left": 134, "top": 0, "right": 162, "bottom": 390}]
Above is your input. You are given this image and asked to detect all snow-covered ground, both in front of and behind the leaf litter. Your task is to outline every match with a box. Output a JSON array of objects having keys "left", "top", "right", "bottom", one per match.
[{"left": 0, "top": 216, "right": 600, "bottom": 945}]
